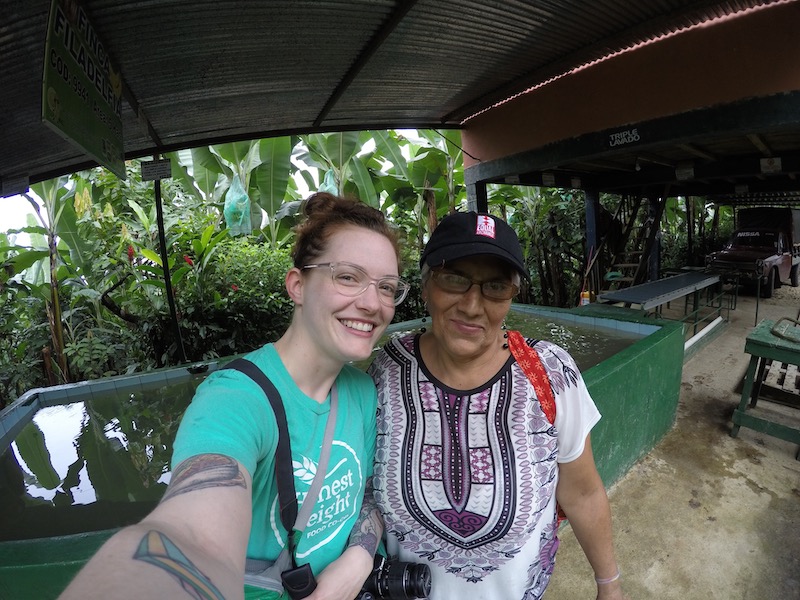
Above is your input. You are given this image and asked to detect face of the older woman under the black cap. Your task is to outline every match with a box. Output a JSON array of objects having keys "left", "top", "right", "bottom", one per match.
[{"left": 422, "top": 255, "right": 512, "bottom": 361}]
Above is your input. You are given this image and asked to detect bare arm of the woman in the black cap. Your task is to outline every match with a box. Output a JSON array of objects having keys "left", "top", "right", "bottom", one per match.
[{"left": 556, "top": 436, "right": 624, "bottom": 600}]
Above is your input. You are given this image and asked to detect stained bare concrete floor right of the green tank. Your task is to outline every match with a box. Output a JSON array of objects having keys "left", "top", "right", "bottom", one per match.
[{"left": 545, "top": 286, "right": 800, "bottom": 600}]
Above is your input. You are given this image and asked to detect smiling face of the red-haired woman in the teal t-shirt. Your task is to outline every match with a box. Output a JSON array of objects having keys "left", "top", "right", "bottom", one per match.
[{"left": 287, "top": 225, "right": 398, "bottom": 363}]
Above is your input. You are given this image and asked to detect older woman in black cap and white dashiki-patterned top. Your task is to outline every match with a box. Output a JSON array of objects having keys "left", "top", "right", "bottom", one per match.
[{"left": 370, "top": 212, "right": 623, "bottom": 600}]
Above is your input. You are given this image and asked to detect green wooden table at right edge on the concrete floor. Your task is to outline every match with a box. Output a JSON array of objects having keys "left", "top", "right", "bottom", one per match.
[{"left": 731, "top": 318, "right": 800, "bottom": 459}]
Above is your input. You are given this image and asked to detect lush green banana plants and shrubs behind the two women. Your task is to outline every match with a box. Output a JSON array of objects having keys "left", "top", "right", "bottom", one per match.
[{"left": 0, "top": 131, "right": 719, "bottom": 407}]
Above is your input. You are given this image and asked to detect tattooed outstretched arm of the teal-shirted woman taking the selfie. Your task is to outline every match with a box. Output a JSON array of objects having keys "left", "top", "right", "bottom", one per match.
[{"left": 59, "top": 454, "right": 252, "bottom": 600}]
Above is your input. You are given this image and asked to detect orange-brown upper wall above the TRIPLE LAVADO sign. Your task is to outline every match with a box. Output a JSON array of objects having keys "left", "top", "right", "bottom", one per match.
[{"left": 462, "top": 2, "right": 800, "bottom": 167}]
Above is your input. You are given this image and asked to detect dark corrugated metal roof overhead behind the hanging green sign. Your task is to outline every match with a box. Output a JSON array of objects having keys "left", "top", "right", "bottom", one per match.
[{"left": 0, "top": 0, "right": 792, "bottom": 190}]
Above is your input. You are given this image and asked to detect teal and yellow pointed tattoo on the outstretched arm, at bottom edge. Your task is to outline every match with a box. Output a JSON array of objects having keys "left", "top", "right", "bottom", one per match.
[{"left": 133, "top": 531, "right": 225, "bottom": 600}]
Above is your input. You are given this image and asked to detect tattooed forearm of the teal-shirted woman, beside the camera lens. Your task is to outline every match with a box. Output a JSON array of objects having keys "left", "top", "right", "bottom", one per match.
[{"left": 308, "top": 477, "right": 383, "bottom": 600}]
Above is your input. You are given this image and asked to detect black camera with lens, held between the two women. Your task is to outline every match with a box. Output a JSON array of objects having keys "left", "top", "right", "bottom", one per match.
[{"left": 356, "top": 554, "right": 431, "bottom": 600}]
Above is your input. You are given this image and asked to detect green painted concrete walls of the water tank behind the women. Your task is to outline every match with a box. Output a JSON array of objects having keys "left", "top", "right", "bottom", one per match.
[{"left": 0, "top": 305, "right": 684, "bottom": 600}]
